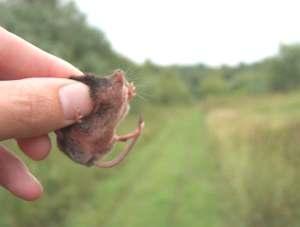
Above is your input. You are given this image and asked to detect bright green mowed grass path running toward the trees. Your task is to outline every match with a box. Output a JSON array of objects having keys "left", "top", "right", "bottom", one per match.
[{"left": 65, "top": 108, "right": 218, "bottom": 227}]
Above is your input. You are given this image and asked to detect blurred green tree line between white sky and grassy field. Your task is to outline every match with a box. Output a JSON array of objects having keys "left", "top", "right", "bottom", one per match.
[{"left": 0, "top": 0, "right": 300, "bottom": 105}]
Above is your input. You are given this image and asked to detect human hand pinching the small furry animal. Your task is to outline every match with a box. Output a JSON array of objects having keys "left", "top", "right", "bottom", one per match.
[{"left": 0, "top": 27, "right": 92, "bottom": 200}]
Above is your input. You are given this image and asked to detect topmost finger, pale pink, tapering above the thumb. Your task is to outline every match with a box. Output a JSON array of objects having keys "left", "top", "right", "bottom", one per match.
[{"left": 0, "top": 27, "right": 82, "bottom": 80}]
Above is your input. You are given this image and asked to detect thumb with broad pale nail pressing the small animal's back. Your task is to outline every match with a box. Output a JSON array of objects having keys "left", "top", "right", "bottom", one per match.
[{"left": 0, "top": 78, "right": 92, "bottom": 139}]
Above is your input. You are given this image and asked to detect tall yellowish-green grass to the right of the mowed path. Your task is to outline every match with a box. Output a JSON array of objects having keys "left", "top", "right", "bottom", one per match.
[{"left": 207, "top": 94, "right": 300, "bottom": 227}]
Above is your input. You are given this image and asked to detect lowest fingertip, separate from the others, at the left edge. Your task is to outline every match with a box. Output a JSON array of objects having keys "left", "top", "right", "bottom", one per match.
[{"left": 0, "top": 147, "right": 43, "bottom": 201}]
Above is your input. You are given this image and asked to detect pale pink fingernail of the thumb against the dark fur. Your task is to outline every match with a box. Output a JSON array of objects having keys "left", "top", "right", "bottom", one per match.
[{"left": 59, "top": 82, "right": 92, "bottom": 121}]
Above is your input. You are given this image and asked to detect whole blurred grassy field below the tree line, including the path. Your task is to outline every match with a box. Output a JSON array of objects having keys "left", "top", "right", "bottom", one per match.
[{"left": 0, "top": 94, "right": 300, "bottom": 227}]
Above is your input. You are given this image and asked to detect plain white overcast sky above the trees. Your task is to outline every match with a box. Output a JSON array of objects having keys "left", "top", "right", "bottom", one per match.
[{"left": 75, "top": 0, "right": 300, "bottom": 65}]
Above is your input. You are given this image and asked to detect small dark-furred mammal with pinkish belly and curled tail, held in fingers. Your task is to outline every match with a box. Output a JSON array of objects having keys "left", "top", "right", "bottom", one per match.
[{"left": 56, "top": 70, "right": 144, "bottom": 168}]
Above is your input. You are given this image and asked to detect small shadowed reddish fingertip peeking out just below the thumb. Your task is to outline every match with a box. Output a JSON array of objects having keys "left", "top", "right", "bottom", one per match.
[{"left": 17, "top": 135, "right": 51, "bottom": 161}]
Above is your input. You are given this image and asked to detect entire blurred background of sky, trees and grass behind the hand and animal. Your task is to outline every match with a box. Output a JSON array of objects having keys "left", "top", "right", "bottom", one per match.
[{"left": 0, "top": 0, "right": 300, "bottom": 227}]
